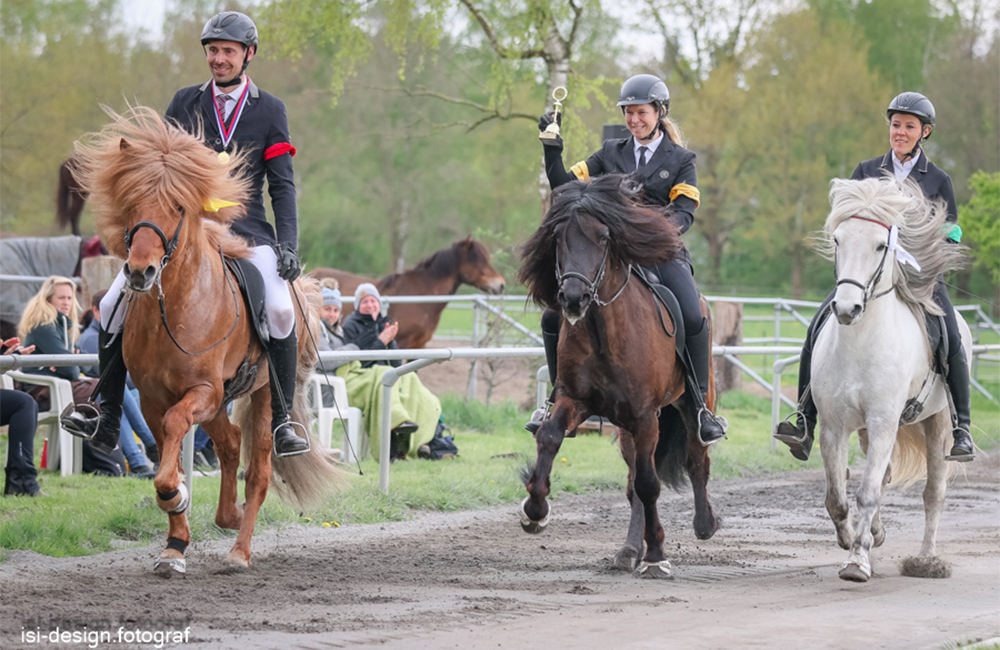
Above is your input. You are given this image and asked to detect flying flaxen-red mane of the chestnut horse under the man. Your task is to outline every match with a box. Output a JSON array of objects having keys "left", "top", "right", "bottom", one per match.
[{"left": 73, "top": 106, "right": 250, "bottom": 258}]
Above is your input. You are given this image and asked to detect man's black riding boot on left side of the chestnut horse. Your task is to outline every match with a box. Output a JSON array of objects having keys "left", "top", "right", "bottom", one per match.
[{"left": 60, "top": 327, "right": 128, "bottom": 454}]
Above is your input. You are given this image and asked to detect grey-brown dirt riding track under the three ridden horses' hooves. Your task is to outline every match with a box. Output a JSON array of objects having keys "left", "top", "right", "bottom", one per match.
[{"left": 0, "top": 453, "right": 1000, "bottom": 650}]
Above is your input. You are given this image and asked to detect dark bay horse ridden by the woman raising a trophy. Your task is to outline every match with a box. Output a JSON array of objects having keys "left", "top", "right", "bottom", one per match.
[{"left": 518, "top": 175, "right": 718, "bottom": 578}]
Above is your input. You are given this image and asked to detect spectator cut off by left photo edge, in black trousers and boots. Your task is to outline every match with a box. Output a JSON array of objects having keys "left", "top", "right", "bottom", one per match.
[{"left": 0, "top": 337, "right": 48, "bottom": 497}]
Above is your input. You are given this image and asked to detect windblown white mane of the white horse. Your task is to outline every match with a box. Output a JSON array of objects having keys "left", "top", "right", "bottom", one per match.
[{"left": 817, "top": 174, "right": 966, "bottom": 314}]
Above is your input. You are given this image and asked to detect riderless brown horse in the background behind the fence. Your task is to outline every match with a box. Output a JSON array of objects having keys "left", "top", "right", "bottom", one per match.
[{"left": 309, "top": 237, "right": 504, "bottom": 349}]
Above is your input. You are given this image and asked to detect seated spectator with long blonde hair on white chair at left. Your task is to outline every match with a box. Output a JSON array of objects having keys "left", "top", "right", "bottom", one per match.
[{"left": 17, "top": 275, "right": 125, "bottom": 476}]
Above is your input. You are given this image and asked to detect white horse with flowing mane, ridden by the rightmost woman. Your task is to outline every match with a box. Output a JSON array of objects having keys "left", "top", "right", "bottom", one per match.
[{"left": 812, "top": 178, "right": 972, "bottom": 582}]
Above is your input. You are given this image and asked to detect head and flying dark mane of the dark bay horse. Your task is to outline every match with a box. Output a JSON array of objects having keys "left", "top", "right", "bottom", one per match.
[{"left": 518, "top": 174, "right": 681, "bottom": 321}]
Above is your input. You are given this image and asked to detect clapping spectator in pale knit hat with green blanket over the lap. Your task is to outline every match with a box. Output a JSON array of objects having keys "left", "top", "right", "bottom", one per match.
[{"left": 337, "top": 282, "right": 441, "bottom": 460}]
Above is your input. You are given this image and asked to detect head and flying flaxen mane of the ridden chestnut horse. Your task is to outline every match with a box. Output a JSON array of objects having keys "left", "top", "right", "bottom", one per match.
[{"left": 74, "top": 106, "right": 250, "bottom": 291}]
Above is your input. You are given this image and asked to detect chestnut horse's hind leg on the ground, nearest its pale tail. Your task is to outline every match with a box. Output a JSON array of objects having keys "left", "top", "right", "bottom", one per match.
[{"left": 227, "top": 386, "right": 273, "bottom": 567}]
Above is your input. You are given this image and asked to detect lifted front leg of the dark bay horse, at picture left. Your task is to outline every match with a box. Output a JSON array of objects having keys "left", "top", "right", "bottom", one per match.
[{"left": 521, "top": 396, "right": 589, "bottom": 533}]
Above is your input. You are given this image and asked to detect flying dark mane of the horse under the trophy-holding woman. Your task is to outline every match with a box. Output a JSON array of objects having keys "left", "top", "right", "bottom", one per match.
[{"left": 517, "top": 174, "right": 682, "bottom": 309}]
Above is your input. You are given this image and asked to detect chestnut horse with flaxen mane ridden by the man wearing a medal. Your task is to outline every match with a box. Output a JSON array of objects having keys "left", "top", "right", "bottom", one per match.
[{"left": 70, "top": 107, "right": 343, "bottom": 577}]
